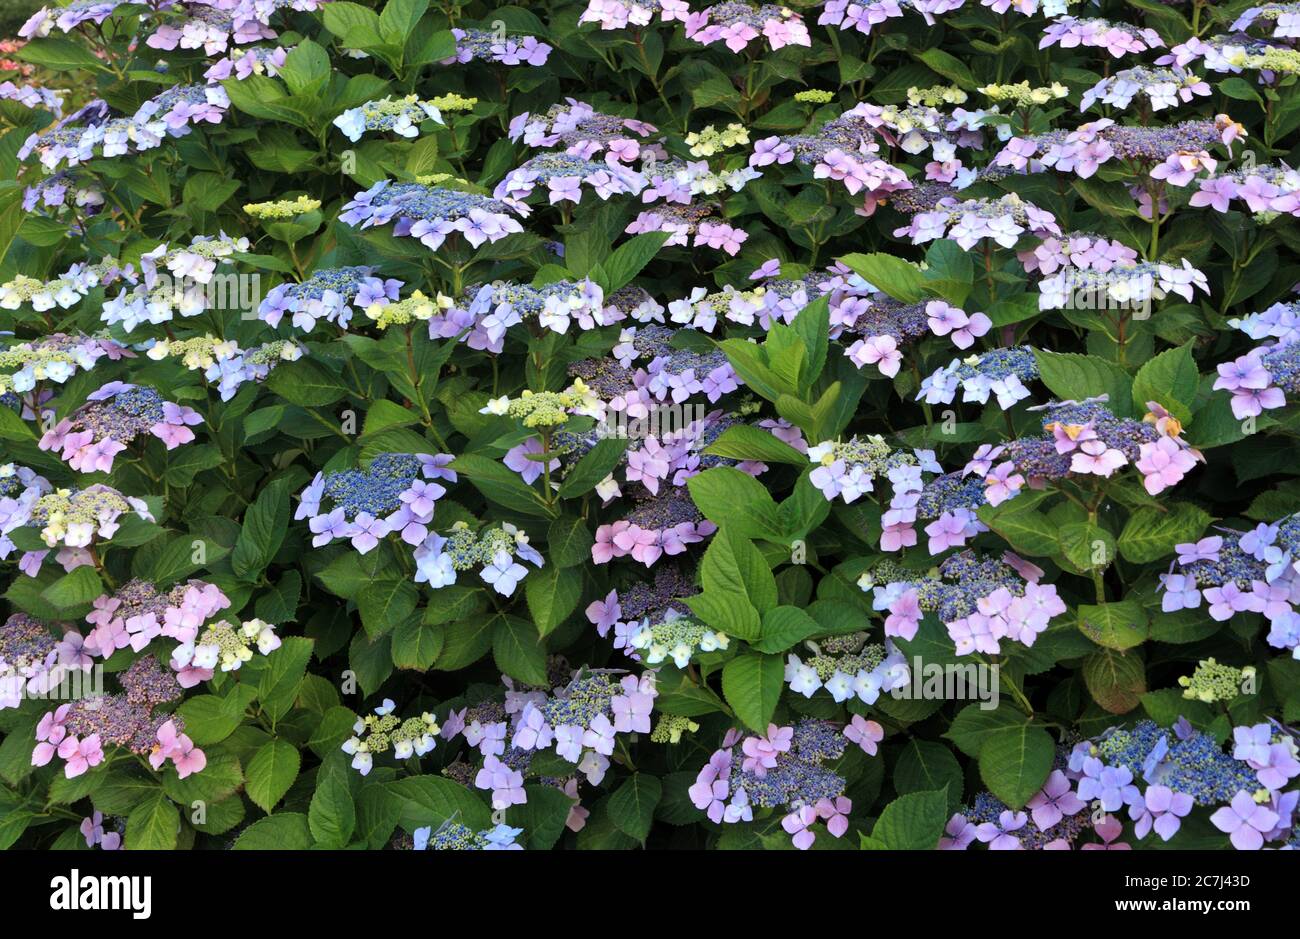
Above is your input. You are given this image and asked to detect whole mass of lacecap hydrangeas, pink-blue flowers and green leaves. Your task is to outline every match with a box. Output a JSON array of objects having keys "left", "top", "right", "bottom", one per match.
[{"left": 0, "top": 0, "right": 1300, "bottom": 849}]
